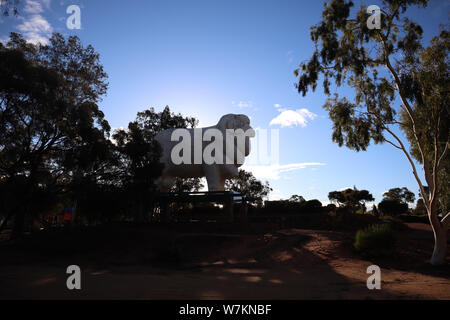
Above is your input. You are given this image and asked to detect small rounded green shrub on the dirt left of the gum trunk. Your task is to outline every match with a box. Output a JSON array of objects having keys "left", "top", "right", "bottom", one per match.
[{"left": 354, "top": 224, "right": 395, "bottom": 256}]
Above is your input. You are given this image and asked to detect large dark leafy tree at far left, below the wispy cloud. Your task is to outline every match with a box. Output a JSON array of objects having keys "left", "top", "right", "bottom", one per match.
[{"left": 0, "top": 33, "right": 109, "bottom": 235}]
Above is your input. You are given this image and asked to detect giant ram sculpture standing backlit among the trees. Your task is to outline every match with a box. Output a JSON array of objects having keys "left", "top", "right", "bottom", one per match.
[{"left": 155, "top": 114, "right": 255, "bottom": 191}]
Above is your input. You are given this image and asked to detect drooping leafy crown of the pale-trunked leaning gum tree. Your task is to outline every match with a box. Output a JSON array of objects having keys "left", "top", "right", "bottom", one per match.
[{"left": 295, "top": 0, "right": 428, "bottom": 151}]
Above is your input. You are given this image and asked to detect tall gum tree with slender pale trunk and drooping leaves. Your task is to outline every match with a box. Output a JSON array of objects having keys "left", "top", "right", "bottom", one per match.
[{"left": 296, "top": 0, "right": 450, "bottom": 265}]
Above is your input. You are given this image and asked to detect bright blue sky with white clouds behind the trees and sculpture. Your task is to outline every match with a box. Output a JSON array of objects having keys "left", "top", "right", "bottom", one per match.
[{"left": 0, "top": 0, "right": 450, "bottom": 203}]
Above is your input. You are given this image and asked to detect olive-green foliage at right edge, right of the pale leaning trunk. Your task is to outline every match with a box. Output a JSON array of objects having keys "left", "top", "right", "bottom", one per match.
[{"left": 400, "top": 30, "right": 450, "bottom": 212}]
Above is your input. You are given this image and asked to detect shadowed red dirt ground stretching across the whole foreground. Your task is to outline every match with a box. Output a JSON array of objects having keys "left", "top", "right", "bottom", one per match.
[{"left": 0, "top": 224, "right": 450, "bottom": 299}]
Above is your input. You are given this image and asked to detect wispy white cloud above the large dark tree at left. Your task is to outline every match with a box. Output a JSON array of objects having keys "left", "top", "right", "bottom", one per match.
[{"left": 17, "top": 0, "right": 53, "bottom": 44}]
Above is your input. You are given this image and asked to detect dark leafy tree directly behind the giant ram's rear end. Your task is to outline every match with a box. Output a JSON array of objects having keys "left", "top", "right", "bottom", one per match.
[{"left": 113, "top": 106, "right": 201, "bottom": 221}]
